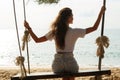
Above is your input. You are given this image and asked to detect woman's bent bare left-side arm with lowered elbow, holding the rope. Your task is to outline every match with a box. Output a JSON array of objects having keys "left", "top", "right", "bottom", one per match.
[{"left": 24, "top": 21, "right": 47, "bottom": 43}]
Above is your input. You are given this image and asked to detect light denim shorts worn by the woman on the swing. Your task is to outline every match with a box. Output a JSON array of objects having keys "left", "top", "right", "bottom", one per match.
[{"left": 52, "top": 53, "right": 79, "bottom": 73}]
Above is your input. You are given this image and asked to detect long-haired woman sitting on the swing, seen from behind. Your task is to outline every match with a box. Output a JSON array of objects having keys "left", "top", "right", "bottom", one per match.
[{"left": 24, "top": 6, "right": 105, "bottom": 80}]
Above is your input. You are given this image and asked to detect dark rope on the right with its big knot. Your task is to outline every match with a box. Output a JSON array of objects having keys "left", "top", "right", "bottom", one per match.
[{"left": 96, "top": 0, "right": 109, "bottom": 70}]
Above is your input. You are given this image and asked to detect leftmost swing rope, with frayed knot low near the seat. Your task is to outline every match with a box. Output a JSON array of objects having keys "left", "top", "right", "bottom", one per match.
[{"left": 13, "top": 0, "right": 26, "bottom": 80}]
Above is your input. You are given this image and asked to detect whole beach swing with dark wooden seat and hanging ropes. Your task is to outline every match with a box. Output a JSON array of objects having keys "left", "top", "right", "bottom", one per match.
[{"left": 11, "top": 0, "right": 111, "bottom": 80}]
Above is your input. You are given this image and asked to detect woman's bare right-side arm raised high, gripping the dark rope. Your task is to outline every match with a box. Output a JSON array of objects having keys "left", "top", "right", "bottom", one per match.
[{"left": 86, "top": 6, "right": 105, "bottom": 34}]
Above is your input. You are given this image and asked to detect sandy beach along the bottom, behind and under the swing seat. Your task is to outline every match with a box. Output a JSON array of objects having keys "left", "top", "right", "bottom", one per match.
[{"left": 0, "top": 67, "right": 120, "bottom": 80}]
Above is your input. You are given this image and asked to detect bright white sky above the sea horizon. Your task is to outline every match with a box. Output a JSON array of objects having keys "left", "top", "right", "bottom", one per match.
[{"left": 0, "top": 0, "right": 120, "bottom": 29}]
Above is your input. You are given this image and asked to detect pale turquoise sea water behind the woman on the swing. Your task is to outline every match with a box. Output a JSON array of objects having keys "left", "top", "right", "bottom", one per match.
[{"left": 0, "top": 29, "right": 120, "bottom": 67}]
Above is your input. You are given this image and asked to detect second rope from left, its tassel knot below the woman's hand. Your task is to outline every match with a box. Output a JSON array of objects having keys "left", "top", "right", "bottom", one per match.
[{"left": 22, "top": 0, "right": 30, "bottom": 74}]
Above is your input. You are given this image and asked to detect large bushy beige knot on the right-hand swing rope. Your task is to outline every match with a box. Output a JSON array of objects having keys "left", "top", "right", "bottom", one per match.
[{"left": 96, "top": 36, "right": 109, "bottom": 58}]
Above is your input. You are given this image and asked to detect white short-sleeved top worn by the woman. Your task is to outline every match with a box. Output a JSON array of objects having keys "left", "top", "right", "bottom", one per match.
[{"left": 45, "top": 28, "right": 86, "bottom": 52}]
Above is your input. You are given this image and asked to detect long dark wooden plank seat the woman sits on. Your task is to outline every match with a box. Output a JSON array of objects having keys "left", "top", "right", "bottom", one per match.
[{"left": 11, "top": 69, "right": 111, "bottom": 80}]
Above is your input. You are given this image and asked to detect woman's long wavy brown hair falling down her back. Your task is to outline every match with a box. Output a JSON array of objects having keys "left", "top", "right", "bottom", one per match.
[{"left": 51, "top": 7, "right": 72, "bottom": 49}]
